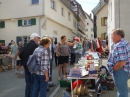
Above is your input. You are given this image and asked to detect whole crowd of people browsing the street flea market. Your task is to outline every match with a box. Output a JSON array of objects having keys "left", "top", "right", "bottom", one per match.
[{"left": 0, "top": 29, "right": 130, "bottom": 97}]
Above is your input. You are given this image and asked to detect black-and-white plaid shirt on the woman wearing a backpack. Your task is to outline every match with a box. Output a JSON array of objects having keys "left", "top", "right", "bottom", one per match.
[{"left": 34, "top": 45, "right": 50, "bottom": 75}]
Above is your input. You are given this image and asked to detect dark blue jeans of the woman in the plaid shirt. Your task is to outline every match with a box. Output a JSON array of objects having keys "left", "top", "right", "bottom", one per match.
[{"left": 32, "top": 73, "right": 48, "bottom": 97}]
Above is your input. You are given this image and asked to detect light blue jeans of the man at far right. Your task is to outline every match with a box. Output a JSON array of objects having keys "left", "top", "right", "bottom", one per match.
[{"left": 113, "top": 68, "right": 128, "bottom": 97}]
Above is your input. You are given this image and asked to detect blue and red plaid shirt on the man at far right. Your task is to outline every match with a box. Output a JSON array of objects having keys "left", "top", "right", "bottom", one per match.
[{"left": 107, "top": 38, "right": 130, "bottom": 75}]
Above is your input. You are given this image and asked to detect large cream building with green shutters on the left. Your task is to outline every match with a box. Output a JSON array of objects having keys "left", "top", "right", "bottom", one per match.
[{"left": 0, "top": 0, "right": 78, "bottom": 45}]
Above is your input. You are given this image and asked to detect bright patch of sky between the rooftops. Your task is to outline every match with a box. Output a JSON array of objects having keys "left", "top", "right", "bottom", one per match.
[{"left": 76, "top": 0, "right": 100, "bottom": 14}]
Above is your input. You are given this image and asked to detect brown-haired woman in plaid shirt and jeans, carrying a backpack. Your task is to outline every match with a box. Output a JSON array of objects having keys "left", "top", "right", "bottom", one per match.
[{"left": 32, "top": 37, "right": 51, "bottom": 97}]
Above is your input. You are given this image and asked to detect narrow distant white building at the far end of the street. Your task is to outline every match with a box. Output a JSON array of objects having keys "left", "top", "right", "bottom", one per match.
[{"left": 85, "top": 13, "right": 94, "bottom": 39}]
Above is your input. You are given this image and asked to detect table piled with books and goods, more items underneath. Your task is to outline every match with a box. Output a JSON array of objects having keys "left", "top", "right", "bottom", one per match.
[{"left": 67, "top": 52, "right": 101, "bottom": 97}]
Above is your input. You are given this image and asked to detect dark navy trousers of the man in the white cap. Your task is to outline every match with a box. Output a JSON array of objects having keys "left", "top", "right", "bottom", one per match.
[{"left": 25, "top": 69, "right": 33, "bottom": 97}]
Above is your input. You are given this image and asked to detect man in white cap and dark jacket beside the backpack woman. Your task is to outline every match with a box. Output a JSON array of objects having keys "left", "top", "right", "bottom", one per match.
[{"left": 21, "top": 33, "right": 40, "bottom": 97}]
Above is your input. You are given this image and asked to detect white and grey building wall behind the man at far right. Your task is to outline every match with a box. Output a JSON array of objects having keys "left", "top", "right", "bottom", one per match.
[{"left": 107, "top": 0, "right": 130, "bottom": 47}]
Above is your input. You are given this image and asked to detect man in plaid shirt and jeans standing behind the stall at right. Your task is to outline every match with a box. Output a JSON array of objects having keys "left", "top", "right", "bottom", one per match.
[{"left": 107, "top": 29, "right": 130, "bottom": 97}]
